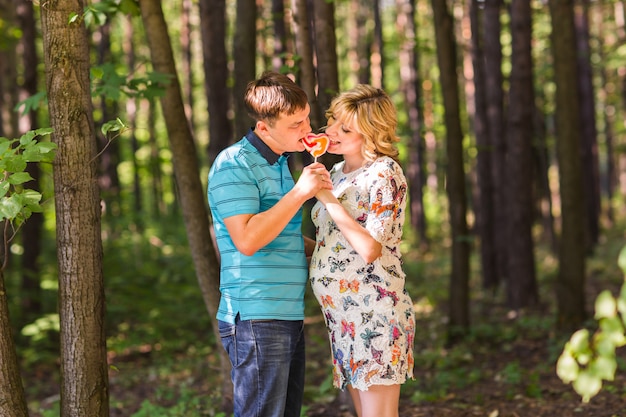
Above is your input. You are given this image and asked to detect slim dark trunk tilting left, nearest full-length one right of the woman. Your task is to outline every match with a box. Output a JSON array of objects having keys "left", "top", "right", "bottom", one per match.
[{"left": 432, "top": 0, "right": 470, "bottom": 343}]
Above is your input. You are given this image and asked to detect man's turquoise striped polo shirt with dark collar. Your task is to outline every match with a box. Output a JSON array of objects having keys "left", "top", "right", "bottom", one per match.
[{"left": 208, "top": 130, "right": 308, "bottom": 323}]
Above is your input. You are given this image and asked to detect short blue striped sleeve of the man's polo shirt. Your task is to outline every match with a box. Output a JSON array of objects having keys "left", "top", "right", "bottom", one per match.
[{"left": 208, "top": 153, "right": 260, "bottom": 219}]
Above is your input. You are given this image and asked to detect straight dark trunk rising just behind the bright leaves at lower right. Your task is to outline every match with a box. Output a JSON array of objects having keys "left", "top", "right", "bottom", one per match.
[{"left": 549, "top": 0, "right": 586, "bottom": 331}]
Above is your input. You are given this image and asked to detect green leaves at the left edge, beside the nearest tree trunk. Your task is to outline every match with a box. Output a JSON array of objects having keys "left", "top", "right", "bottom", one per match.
[{"left": 0, "top": 128, "right": 56, "bottom": 226}]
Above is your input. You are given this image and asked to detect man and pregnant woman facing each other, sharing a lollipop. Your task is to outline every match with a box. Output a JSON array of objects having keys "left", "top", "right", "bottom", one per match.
[{"left": 208, "top": 72, "right": 415, "bottom": 417}]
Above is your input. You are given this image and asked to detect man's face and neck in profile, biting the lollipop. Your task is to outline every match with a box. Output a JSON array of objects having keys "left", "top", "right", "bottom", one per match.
[{"left": 255, "top": 104, "right": 311, "bottom": 155}]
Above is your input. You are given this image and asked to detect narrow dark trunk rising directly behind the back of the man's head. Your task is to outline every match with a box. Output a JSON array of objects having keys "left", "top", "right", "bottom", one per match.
[{"left": 232, "top": 0, "right": 257, "bottom": 137}]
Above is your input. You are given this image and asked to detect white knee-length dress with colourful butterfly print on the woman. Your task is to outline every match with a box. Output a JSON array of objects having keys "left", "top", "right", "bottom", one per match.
[{"left": 309, "top": 157, "right": 415, "bottom": 390}]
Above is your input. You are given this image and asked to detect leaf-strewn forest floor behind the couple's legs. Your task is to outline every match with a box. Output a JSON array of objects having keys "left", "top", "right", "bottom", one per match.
[{"left": 29, "top": 302, "right": 626, "bottom": 417}]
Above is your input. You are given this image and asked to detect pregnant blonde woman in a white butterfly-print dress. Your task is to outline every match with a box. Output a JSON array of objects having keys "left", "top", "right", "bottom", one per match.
[{"left": 309, "top": 85, "right": 415, "bottom": 417}]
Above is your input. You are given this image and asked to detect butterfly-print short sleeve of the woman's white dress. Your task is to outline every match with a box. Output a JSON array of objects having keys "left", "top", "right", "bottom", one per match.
[{"left": 365, "top": 159, "right": 407, "bottom": 245}]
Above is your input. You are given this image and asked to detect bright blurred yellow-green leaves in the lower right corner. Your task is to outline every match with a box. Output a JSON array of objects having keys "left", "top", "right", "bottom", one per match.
[{"left": 556, "top": 247, "right": 626, "bottom": 402}]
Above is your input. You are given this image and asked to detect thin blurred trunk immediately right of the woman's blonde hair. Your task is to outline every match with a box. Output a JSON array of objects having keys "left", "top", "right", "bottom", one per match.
[{"left": 396, "top": 0, "right": 428, "bottom": 248}]
